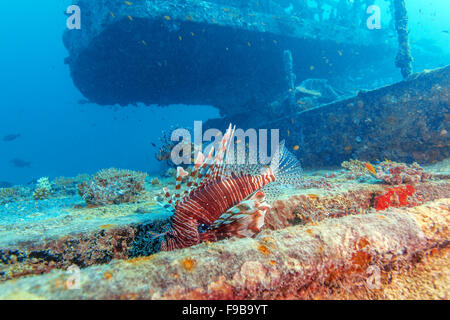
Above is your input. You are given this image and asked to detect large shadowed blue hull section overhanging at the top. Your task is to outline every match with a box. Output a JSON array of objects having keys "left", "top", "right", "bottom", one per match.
[{"left": 64, "top": 0, "right": 395, "bottom": 115}]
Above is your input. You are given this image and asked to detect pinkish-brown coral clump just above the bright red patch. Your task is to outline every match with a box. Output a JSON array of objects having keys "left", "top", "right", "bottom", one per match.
[{"left": 376, "top": 161, "right": 431, "bottom": 185}]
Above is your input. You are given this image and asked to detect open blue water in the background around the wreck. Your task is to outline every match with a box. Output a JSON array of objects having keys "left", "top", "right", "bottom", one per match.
[{"left": 0, "top": 0, "right": 450, "bottom": 184}]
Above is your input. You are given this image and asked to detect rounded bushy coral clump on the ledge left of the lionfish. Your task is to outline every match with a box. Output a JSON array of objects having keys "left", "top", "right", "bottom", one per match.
[{"left": 78, "top": 168, "right": 147, "bottom": 205}]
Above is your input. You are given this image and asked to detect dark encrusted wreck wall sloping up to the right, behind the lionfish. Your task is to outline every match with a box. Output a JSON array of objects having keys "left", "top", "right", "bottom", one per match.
[{"left": 206, "top": 66, "right": 450, "bottom": 167}]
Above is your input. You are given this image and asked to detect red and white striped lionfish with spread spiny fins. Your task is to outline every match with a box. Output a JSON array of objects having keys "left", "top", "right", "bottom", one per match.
[{"left": 156, "top": 124, "right": 302, "bottom": 251}]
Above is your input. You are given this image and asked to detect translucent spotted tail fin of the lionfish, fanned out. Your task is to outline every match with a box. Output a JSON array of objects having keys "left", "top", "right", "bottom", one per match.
[{"left": 270, "top": 140, "right": 303, "bottom": 185}]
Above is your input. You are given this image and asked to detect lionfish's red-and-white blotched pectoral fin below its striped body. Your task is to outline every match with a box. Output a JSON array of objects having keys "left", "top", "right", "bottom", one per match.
[{"left": 208, "top": 198, "right": 270, "bottom": 239}]
